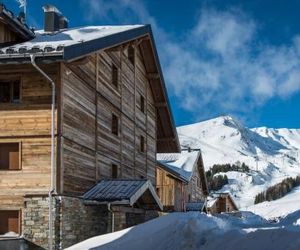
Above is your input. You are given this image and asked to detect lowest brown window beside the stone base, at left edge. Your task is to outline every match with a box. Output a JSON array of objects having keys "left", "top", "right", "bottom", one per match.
[{"left": 0, "top": 210, "right": 20, "bottom": 235}]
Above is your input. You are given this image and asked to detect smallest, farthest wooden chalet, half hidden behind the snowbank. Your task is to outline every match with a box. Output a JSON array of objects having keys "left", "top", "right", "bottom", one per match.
[{"left": 207, "top": 193, "right": 239, "bottom": 214}]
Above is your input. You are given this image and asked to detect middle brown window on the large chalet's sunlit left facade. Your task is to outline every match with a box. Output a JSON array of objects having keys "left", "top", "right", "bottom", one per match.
[{"left": 0, "top": 143, "right": 21, "bottom": 170}]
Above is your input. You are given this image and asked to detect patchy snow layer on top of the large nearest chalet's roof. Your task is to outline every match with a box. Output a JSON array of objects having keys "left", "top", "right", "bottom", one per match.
[{"left": 0, "top": 25, "right": 144, "bottom": 55}]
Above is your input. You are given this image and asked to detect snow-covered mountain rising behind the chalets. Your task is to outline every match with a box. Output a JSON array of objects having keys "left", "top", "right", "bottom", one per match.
[{"left": 177, "top": 116, "right": 300, "bottom": 208}]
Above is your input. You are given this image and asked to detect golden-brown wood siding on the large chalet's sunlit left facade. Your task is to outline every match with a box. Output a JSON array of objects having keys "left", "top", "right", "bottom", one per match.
[{"left": 0, "top": 65, "right": 58, "bottom": 209}]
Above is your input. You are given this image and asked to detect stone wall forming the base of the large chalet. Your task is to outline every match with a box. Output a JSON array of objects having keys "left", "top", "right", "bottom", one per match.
[{"left": 22, "top": 196, "right": 158, "bottom": 249}]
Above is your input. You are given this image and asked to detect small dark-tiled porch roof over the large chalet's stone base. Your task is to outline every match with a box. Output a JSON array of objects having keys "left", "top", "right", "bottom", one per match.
[{"left": 83, "top": 180, "right": 162, "bottom": 210}]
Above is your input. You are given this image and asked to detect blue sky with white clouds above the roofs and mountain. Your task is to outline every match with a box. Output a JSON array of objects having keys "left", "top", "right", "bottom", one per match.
[{"left": 3, "top": 0, "right": 300, "bottom": 128}]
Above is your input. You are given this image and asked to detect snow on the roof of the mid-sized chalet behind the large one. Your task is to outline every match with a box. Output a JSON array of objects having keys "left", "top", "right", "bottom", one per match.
[{"left": 157, "top": 151, "right": 200, "bottom": 181}]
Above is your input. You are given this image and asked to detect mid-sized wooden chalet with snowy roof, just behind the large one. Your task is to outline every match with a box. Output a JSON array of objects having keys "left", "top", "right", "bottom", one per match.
[{"left": 156, "top": 150, "right": 208, "bottom": 211}]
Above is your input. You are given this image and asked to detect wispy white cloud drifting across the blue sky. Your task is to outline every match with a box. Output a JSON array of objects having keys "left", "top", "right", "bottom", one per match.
[{"left": 83, "top": 0, "right": 300, "bottom": 124}]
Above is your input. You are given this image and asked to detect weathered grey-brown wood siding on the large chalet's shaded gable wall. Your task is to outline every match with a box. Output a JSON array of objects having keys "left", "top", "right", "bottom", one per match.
[{"left": 61, "top": 43, "right": 156, "bottom": 194}]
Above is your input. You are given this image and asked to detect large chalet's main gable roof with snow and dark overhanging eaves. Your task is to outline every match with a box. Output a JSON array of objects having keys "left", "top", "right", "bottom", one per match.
[{"left": 0, "top": 25, "right": 180, "bottom": 153}]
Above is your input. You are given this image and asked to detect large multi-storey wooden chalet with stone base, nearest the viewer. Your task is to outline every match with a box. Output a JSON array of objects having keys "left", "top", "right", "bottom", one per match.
[{"left": 0, "top": 5, "right": 180, "bottom": 249}]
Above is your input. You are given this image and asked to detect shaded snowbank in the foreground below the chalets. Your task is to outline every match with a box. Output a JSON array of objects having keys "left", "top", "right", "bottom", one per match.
[{"left": 68, "top": 211, "right": 300, "bottom": 250}]
